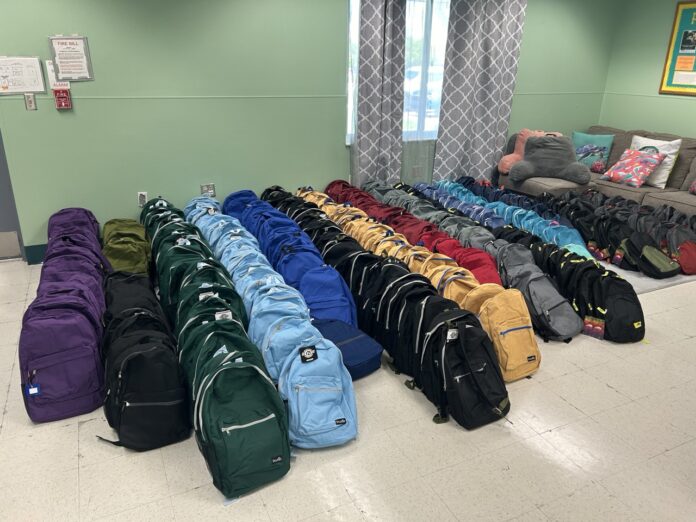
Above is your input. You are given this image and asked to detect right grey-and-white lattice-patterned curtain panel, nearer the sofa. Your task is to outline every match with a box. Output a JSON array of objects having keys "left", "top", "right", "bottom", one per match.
[{"left": 433, "top": 0, "right": 527, "bottom": 180}]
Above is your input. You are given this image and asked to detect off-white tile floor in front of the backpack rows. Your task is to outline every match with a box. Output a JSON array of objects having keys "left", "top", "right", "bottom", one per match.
[{"left": 0, "top": 256, "right": 696, "bottom": 522}]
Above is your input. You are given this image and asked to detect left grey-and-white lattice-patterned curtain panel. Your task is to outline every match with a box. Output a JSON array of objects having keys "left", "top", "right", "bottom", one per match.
[{"left": 351, "top": 0, "right": 406, "bottom": 186}]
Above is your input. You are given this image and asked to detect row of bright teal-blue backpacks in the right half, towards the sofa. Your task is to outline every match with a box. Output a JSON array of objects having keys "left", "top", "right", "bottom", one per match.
[{"left": 432, "top": 180, "right": 591, "bottom": 258}]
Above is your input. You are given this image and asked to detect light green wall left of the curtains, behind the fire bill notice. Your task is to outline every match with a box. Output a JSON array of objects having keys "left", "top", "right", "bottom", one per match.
[{"left": 0, "top": 0, "right": 349, "bottom": 245}]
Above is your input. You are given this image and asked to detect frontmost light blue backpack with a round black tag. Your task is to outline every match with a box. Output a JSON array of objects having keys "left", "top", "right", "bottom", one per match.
[{"left": 278, "top": 327, "right": 358, "bottom": 448}]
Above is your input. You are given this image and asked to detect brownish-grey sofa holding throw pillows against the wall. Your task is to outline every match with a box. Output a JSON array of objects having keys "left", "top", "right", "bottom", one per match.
[{"left": 497, "top": 125, "right": 696, "bottom": 215}]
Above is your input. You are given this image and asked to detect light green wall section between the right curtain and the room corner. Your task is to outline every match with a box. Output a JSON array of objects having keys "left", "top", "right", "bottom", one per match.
[{"left": 510, "top": 0, "right": 619, "bottom": 133}]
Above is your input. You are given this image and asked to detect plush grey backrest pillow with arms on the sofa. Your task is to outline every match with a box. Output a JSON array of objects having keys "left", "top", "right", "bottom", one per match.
[{"left": 510, "top": 136, "right": 590, "bottom": 185}]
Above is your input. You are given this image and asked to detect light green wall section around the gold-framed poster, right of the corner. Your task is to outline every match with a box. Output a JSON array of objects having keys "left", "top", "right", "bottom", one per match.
[{"left": 600, "top": 0, "right": 696, "bottom": 136}]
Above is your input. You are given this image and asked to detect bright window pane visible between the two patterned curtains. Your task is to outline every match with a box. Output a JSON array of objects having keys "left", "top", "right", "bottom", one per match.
[{"left": 403, "top": 0, "right": 450, "bottom": 141}]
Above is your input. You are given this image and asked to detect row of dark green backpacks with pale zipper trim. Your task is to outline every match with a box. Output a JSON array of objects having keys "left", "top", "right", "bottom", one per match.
[{"left": 140, "top": 198, "right": 290, "bottom": 498}]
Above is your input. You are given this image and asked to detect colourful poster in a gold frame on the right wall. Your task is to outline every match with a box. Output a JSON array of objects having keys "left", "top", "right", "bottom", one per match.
[{"left": 660, "top": 2, "right": 696, "bottom": 96}]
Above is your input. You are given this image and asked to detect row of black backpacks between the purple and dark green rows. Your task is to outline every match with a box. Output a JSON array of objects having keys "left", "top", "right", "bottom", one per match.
[{"left": 100, "top": 270, "right": 191, "bottom": 451}]
